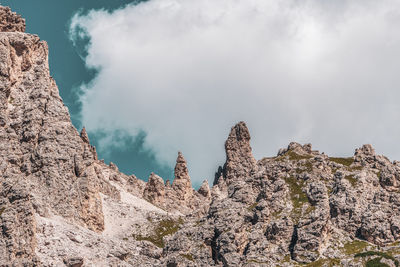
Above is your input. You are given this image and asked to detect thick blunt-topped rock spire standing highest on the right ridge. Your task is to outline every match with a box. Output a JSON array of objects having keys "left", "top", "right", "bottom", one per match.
[{"left": 224, "top": 121, "right": 257, "bottom": 179}]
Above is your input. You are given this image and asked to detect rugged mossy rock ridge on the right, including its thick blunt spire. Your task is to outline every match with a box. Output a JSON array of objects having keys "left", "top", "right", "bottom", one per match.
[{"left": 164, "top": 128, "right": 400, "bottom": 266}]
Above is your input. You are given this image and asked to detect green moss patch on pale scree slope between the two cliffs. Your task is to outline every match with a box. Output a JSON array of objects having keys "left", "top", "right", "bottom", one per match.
[{"left": 133, "top": 218, "right": 183, "bottom": 248}]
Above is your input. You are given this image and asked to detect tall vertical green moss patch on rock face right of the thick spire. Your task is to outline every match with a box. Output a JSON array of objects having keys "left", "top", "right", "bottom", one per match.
[{"left": 285, "top": 177, "right": 309, "bottom": 222}]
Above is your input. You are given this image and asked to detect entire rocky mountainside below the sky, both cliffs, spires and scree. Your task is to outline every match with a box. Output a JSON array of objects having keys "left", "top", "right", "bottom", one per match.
[{"left": 0, "top": 7, "right": 400, "bottom": 266}]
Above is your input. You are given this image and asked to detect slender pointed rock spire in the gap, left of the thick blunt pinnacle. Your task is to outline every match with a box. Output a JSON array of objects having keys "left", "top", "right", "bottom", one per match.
[{"left": 172, "top": 152, "right": 193, "bottom": 200}]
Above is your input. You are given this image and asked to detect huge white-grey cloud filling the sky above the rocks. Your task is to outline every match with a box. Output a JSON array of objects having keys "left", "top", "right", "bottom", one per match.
[{"left": 71, "top": 0, "right": 400, "bottom": 184}]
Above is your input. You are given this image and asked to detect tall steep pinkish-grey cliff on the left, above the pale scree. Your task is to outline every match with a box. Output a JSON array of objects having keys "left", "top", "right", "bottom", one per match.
[{"left": 0, "top": 6, "right": 117, "bottom": 264}]
